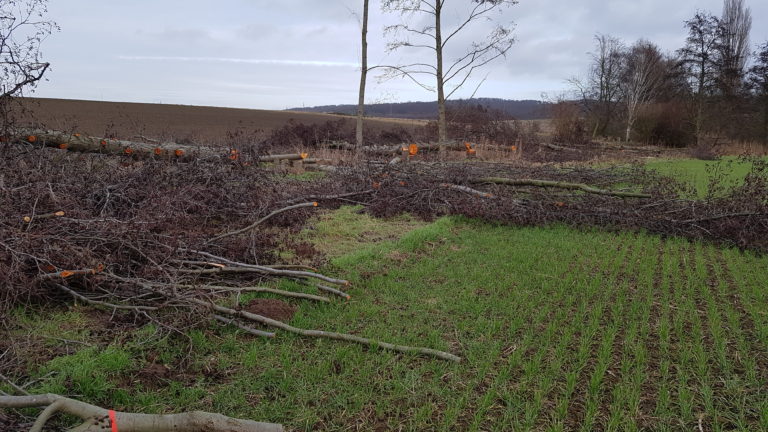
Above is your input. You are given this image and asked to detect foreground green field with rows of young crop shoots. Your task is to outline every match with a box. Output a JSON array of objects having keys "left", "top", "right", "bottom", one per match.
[{"left": 7, "top": 208, "right": 768, "bottom": 431}]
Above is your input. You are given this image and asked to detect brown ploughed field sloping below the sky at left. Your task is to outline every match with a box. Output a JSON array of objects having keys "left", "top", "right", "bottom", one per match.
[{"left": 15, "top": 98, "right": 412, "bottom": 144}]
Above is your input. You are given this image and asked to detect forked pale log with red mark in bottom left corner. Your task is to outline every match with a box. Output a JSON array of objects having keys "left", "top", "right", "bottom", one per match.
[{"left": 0, "top": 394, "right": 284, "bottom": 432}]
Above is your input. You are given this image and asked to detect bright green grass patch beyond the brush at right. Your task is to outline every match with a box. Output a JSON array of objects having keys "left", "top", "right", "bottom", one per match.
[{"left": 646, "top": 156, "right": 764, "bottom": 198}]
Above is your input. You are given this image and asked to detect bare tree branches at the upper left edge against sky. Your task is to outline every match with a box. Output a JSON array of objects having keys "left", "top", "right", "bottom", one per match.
[{"left": 0, "top": 0, "right": 58, "bottom": 136}]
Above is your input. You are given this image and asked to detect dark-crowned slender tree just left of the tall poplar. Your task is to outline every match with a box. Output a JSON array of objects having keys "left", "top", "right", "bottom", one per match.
[{"left": 678, "top": 11, "right": 723, "bottom": 145}]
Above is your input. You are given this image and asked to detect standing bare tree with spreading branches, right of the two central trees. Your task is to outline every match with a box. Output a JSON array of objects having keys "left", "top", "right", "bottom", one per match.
[{"left": 383, "top": 0, "right": 518, "bottom": 143}]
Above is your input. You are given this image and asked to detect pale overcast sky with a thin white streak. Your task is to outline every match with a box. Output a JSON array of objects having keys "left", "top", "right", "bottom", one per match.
[{"left": 35, "top": 0, "right": 768, "bottom": 109}]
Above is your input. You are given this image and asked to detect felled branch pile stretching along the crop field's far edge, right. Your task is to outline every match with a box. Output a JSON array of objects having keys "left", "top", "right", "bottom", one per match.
[{"left": 334, "top": 160, "right": 768, "bottom": 251}]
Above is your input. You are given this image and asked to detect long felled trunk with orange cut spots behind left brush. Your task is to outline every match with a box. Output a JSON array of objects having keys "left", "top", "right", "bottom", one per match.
[{"left": 16, "top": 130, "right": 309, "bottom": 162}]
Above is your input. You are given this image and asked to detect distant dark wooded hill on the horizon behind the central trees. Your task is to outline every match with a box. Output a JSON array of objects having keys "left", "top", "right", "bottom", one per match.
[{"left": 290, "top": 98, "right": 549, "bottom": 120}]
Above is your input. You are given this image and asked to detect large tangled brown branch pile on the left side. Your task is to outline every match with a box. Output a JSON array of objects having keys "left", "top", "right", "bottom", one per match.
[{"left": 0, "top": 147, "right": 459, "bottom": 361}]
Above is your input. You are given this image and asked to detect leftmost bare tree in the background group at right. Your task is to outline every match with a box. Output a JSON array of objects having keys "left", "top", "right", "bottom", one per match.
[{"left": 570, "top": 34, "right": 624, "bottom": 138}]
